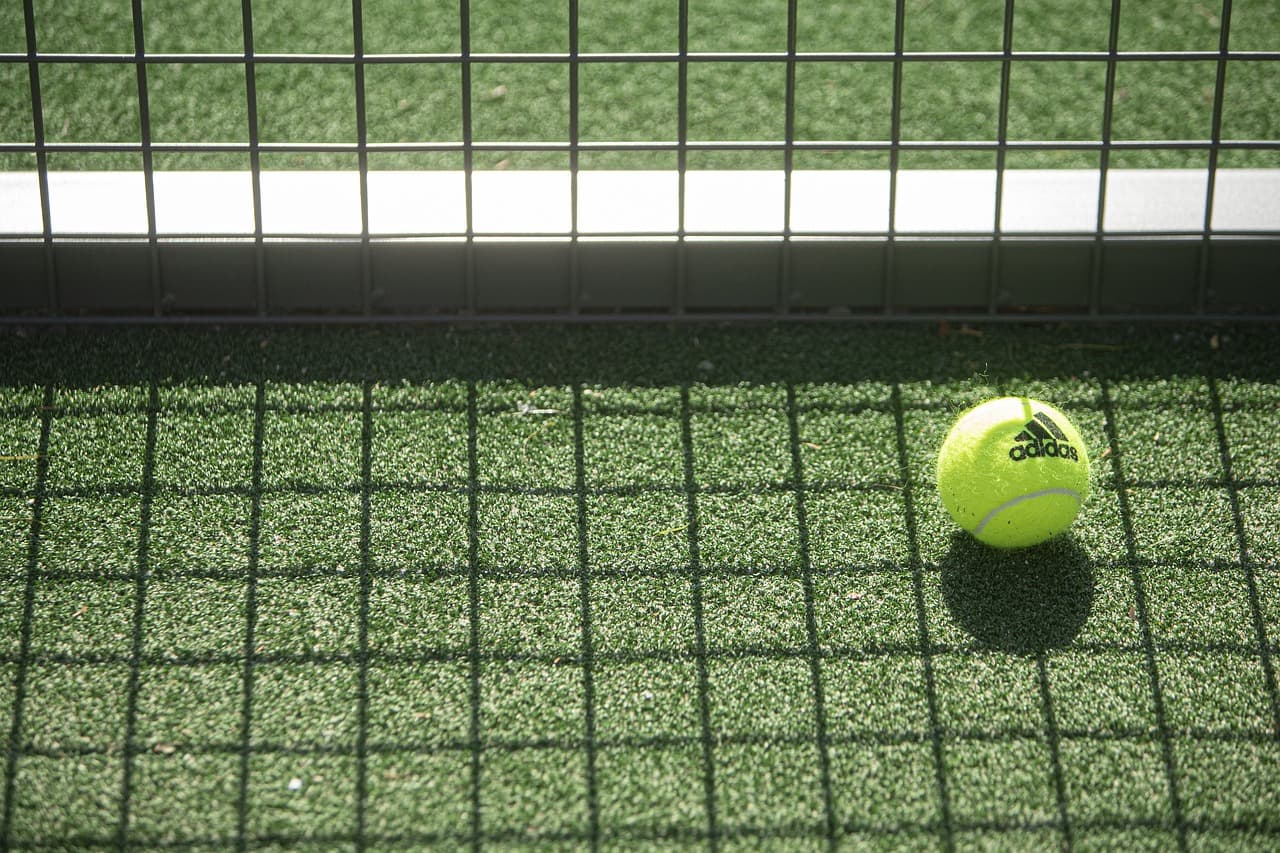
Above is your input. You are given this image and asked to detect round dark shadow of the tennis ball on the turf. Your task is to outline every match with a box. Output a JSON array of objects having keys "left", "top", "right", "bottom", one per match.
[{"left": 941, "top": 532, "right": 1094, "bottom": 654}]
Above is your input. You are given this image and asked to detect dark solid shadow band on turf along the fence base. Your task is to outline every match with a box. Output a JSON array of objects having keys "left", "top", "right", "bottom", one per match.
[{"left": 0, "top": 324, "right": 1280, "bottom": 388}]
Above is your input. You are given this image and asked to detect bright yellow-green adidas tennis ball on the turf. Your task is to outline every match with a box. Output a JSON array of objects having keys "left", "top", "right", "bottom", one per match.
[{"left": 938, "top": 397, "right": 1089, "bottom": 548}]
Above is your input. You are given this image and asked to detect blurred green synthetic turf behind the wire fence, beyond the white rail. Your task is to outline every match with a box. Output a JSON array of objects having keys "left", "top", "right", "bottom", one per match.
[{"left": 0, "top": 0, "right": 1280, "bottom": 169}]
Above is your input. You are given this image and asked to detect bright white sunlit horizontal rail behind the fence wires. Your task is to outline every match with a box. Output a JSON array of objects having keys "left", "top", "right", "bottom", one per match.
[{"left": 0, "top": 169, "right": 1280, "bottom": 237}]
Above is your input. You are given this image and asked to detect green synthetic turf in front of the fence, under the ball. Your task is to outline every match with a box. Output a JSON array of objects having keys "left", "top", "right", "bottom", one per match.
[{"left": 0, "top": 327, "right": 1280, "bottom": 849}]
